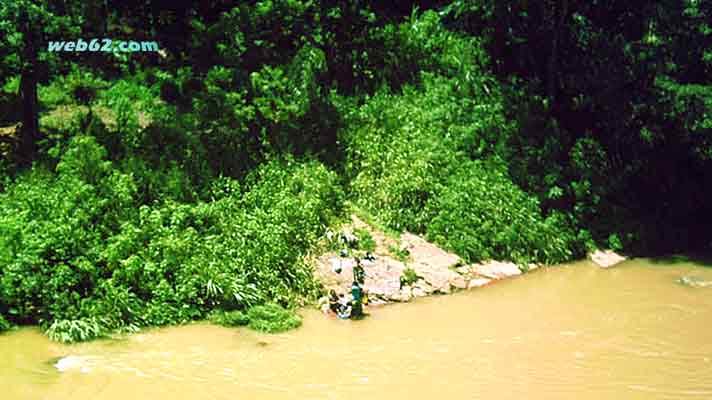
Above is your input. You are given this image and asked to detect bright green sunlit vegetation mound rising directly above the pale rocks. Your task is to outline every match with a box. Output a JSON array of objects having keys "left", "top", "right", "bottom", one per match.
[{"left": 344, "top": 49, "right": 574, "bottom": 263}]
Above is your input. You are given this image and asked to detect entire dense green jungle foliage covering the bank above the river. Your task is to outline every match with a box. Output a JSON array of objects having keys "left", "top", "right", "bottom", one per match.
[{"left": 0, "top": 0, "right": 712, "bottom": 341}]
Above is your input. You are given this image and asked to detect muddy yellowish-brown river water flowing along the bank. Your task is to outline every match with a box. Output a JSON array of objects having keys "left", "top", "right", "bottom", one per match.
[{"left": 0, "top": 260, "right": 712, "bottom": 400}]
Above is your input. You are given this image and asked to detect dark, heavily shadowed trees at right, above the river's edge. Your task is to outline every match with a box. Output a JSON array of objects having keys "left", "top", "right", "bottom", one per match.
[{"left": 445, "top": 0, "right": 712, "bottom": 252}]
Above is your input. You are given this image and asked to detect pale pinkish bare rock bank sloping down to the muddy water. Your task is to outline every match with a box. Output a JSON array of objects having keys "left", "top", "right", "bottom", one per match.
[{"left": 313, "top": 215, "right": 626, "bottom": 310}]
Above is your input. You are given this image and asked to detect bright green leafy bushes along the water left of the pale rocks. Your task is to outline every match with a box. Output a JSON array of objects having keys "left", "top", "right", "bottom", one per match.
[{"left": 0, "top": 135, "right": 343, "bottom": 340}]
